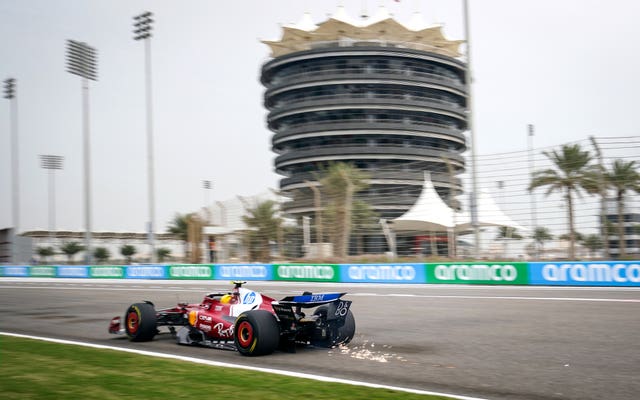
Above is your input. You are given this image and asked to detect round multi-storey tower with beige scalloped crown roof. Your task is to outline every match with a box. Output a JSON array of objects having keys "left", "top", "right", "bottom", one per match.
[{"left": 261, "top": 7, "right": 467, "bottom": 253}]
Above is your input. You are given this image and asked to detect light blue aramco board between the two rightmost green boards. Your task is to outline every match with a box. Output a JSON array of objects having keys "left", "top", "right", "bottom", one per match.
[{"left": 339, "top": 264, "right": 426, "bottom": 283}]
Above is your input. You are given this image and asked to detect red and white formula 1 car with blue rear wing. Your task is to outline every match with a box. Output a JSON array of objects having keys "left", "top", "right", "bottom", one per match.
[{"left": 109, "top": 281, "right": 356, "bottom": 356}]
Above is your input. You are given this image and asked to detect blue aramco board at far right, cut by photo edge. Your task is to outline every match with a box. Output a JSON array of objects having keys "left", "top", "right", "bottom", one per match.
[{"left": 529, "top": 261, "right": 640, "bottom": 286}]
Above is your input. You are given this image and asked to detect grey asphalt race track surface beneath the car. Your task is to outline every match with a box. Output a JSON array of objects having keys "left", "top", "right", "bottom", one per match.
[{"left": 0, "top": 278, "right": 640, "bottom": 400}]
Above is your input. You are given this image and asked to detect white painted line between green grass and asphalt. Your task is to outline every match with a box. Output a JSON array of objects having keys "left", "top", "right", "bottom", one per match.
[{"left": 0, "top": 332, "right": 486, "bottom": 400}]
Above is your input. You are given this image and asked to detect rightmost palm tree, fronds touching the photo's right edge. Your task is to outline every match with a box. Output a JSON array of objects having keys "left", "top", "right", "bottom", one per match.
[{"left": 605, "top": 160, "right": 640, "bottom": 258}]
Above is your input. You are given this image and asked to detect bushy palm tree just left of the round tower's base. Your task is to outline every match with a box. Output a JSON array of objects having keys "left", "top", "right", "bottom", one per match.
[{"left": 242, "top": 200, "right": 282, "bottom": 262}]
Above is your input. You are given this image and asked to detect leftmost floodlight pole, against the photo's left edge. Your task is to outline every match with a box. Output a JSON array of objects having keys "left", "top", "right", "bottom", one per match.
[{"left": 4, "top": 78, "right": 20, "bottom": 263}]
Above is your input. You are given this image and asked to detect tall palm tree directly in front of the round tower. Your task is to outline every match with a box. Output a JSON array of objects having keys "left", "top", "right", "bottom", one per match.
[{"left": 320, "top": 162, "right": 369, "bottom": 257}]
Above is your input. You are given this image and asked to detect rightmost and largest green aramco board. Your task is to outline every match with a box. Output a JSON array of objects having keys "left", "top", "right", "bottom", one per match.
[{"left": 427, "top": 262, "right": 529, "bottom": 285}]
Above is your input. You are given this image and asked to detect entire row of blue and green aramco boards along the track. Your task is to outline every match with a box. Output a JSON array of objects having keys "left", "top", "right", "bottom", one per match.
[{"left": 5, "top": 260, "right": 640, "bottom": 287}]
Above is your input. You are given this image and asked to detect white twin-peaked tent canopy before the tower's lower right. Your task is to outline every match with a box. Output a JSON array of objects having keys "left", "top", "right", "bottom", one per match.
[{"left": 391, "top": 172, "right": 527, "bottom": 231}]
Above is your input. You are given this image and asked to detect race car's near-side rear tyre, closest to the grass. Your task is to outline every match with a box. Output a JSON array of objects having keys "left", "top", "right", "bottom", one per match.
[{"left": 233, "top": 310, "right": 280, "bottom": 356}]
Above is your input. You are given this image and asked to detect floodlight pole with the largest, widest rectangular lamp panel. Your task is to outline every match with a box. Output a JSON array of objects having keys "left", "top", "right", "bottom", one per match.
[{"left": 67, "top": 40, "right": 98, "bottom": 264}]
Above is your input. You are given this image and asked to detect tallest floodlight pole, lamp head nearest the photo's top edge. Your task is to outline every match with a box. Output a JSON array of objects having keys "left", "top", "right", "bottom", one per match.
[{"left": 133, "top": 11, "right": 156, "bottom": 262}]
